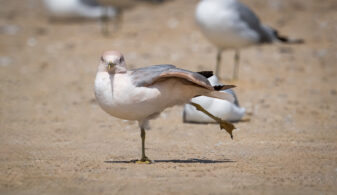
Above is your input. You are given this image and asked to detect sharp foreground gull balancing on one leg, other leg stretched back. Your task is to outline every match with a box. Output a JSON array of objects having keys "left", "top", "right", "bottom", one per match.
[{"left": 95, "top": 51, "right": 235, "bottom": 162}]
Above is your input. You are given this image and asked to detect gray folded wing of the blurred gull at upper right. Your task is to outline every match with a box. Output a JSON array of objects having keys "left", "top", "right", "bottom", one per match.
[{"left": 235, "top": 1, "right": 273, "bottom": 43}]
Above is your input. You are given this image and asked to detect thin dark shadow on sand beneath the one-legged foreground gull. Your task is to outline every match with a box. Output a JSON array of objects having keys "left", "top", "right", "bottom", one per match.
[{"left": 104, "top": 158, "right": 236, "bottom": 164}]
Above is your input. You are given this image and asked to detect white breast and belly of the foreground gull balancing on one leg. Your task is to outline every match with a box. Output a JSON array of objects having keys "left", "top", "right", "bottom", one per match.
[{"left": 95, "top": 72, "right": 200, "bottom": 120}]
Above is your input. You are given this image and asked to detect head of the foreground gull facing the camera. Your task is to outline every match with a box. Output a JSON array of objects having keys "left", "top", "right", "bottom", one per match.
[{"left": 99, "top": 51, "right": 127, "bottom": 74}]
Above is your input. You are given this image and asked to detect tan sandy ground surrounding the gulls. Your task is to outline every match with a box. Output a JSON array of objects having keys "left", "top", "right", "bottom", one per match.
[{"left": 0, "top": 0, "right": 337, "bottom": 194}]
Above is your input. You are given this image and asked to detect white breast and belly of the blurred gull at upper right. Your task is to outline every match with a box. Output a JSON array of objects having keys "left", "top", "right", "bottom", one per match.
[{"left": 195, "top": 0, "right": 259, "bottom": 49}]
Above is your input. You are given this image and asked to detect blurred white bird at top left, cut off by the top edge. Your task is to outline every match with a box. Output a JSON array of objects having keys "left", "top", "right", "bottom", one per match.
[{"left": 43, "top": 0, "right": 119, "bottom": 34}]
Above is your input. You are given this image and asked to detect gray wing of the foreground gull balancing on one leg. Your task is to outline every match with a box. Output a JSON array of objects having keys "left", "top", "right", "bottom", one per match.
[{"left": 131, "top": 64, "right": 214, "bottom": 90}]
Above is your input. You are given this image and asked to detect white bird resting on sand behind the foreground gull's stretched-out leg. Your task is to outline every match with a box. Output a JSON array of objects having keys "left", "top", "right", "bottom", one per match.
[{"left": 183, "top": 75, "right": 246, "bottom": 123}]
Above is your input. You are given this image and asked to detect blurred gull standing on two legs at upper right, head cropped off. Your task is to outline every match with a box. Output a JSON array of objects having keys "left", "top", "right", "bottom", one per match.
[{"left": 195, "top": 0, "right": 303, "bottom": 79}]
